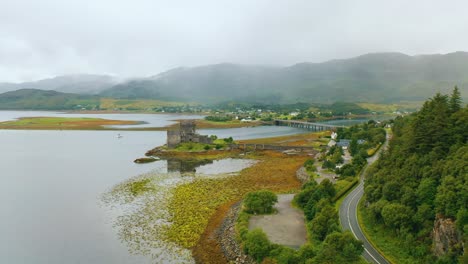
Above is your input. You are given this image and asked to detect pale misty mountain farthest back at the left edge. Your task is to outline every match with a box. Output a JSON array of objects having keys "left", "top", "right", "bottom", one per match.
[{"left": 0, "top": 74, "right": 118, "bottom": 94}]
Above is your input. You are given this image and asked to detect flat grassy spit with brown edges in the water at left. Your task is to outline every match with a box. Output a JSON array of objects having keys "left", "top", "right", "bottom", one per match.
[{"left": 0, "top": 117, "right": 138, "bottom": 130}]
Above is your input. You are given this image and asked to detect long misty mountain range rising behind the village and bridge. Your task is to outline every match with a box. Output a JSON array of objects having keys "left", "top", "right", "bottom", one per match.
[{"left": 100, "top": 52, "right": 468, "bottom": 103}]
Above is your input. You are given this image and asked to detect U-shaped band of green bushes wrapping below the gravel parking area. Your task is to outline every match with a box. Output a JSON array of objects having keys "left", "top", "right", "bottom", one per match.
[{"left": 237, "top": 180, "right": 363, "bottom": 264}]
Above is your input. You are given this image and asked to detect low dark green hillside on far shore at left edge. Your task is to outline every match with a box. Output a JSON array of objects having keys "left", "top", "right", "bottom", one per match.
[{"left": 0, "top": 89, "right": 99, "bottom": 110}]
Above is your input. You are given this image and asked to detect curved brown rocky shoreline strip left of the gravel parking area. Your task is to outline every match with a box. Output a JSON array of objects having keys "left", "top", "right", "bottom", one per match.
[{"left": 216, "top": 202, "right": 256, "bottom": 264}]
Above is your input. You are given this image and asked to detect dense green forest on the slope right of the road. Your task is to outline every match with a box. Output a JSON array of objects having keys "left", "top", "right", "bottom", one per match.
[{"left": 365, "top": 88, "right": 468, "bottom": 263}]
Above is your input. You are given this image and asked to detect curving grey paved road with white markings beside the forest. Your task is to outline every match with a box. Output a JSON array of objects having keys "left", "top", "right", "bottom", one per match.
[{"left": 340, "top": 133, "right": 390, "bottom": 264}]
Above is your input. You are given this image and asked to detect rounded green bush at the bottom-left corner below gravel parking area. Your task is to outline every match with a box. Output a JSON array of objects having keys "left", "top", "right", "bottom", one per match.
[{"left": 244, "top": 228, "right": 271, "bottom": 262}]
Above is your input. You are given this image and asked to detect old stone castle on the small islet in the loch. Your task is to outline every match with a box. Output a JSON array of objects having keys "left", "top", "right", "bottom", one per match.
[{"left": 167, "top": 120, "right": 213, "bottom": 148}]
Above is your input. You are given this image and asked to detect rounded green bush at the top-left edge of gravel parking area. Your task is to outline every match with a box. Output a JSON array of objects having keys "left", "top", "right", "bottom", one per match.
[{"left": 244, "top": 190, "right": 278, "bottom": 214}]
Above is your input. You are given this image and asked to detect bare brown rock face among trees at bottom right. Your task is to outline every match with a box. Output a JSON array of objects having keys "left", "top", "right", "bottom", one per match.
[{"left": 432, "top": 217, "right": 463, "bottom": 257}]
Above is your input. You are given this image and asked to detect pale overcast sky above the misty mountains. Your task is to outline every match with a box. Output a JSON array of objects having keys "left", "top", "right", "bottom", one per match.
[{"left": 0, "top": 0, "right": 468, "bottom": 82}]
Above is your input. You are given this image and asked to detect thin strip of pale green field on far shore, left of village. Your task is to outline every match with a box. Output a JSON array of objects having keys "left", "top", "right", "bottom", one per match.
[{"left": 100, "top": 98, "right": 187, "bottom": 110}]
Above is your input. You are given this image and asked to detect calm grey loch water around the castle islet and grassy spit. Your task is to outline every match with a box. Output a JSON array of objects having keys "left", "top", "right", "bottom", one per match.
[{"left": 0, "top": 111, "right": 304, "bottom": 264}]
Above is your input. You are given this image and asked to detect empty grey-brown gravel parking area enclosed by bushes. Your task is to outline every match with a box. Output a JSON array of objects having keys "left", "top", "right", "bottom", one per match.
[{"left": 249, "top": 194, "right": 307, "bottom": 249}]
